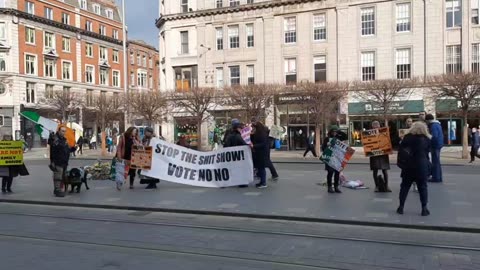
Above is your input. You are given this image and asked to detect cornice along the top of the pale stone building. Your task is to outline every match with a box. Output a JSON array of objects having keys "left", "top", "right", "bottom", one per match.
[{"left": 155, "top": 0, "right": 325, "bottom": 28}]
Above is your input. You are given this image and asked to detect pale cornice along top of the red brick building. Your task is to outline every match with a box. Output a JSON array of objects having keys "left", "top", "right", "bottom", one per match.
[{"left": 0, "top": 8, "right": 123, "bottom": 45}]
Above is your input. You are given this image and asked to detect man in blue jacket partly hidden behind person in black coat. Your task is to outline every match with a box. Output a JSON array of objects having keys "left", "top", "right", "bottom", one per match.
[{"left": 425, "top": 114, "right": 443, "bottom": 183}]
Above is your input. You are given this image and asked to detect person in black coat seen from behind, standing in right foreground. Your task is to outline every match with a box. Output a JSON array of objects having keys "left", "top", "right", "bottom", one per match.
[{"left": 397, "top": 122, "right": 432, "bottom": 216}]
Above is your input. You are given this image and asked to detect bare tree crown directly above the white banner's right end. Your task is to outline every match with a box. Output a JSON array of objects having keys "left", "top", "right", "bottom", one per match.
[{"left": 222, "top": 84, "right": 280, "bottom": 122}]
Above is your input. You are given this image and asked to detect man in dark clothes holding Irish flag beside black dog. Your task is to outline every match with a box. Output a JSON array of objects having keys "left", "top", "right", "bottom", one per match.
[{"left": 50, "top": 126, "right": 71, "bottom": 197}]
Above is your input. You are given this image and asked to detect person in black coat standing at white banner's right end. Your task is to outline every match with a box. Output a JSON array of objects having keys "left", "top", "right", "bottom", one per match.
[{"left": 250, "top": 122, "right": 270, "bottom": 188}]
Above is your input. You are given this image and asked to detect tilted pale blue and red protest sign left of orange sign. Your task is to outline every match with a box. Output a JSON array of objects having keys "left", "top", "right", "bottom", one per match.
[{"left": 320, "top": 138, "right": 355, "bottom": 172}]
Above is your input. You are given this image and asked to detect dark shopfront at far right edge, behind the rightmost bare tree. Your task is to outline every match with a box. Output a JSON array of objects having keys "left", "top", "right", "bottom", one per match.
[{"left": 435, "top": 99, "right": 480, "bottom": 146}]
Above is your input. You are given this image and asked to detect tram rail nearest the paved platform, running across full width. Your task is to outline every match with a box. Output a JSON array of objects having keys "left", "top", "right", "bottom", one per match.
[{"left": 0, "top": 212, "right": 480, "bottom": 252}]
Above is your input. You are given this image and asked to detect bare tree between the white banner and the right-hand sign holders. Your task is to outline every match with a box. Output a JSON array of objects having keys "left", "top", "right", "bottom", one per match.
[{"left": 297, "top": 82, "right": 348, "bottom": 153}]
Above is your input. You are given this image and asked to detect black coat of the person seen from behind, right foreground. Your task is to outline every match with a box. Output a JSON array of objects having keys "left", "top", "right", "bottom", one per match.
[{"left": 400, "top": 134, "right": 432, "bottom": 181}]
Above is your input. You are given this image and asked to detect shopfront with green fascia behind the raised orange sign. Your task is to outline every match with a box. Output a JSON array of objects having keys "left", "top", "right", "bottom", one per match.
[{"left": 348, "top": 100, "right": 424, "bottom": 147}]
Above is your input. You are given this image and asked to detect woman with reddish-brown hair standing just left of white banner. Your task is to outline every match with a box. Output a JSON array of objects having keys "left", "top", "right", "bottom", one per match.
[{"left": 117, "top": 127, "right": 141, "bottom": 189}]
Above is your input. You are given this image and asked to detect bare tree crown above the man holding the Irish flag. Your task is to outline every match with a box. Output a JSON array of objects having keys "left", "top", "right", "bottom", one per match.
[{"left": 42, "top": 90, "right": 84, "bottom": 123}]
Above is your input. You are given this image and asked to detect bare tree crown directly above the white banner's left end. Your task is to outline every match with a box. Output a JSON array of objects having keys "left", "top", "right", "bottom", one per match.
[{"left": 129, "top": 91, "right": 168, "bottom": 125}]
